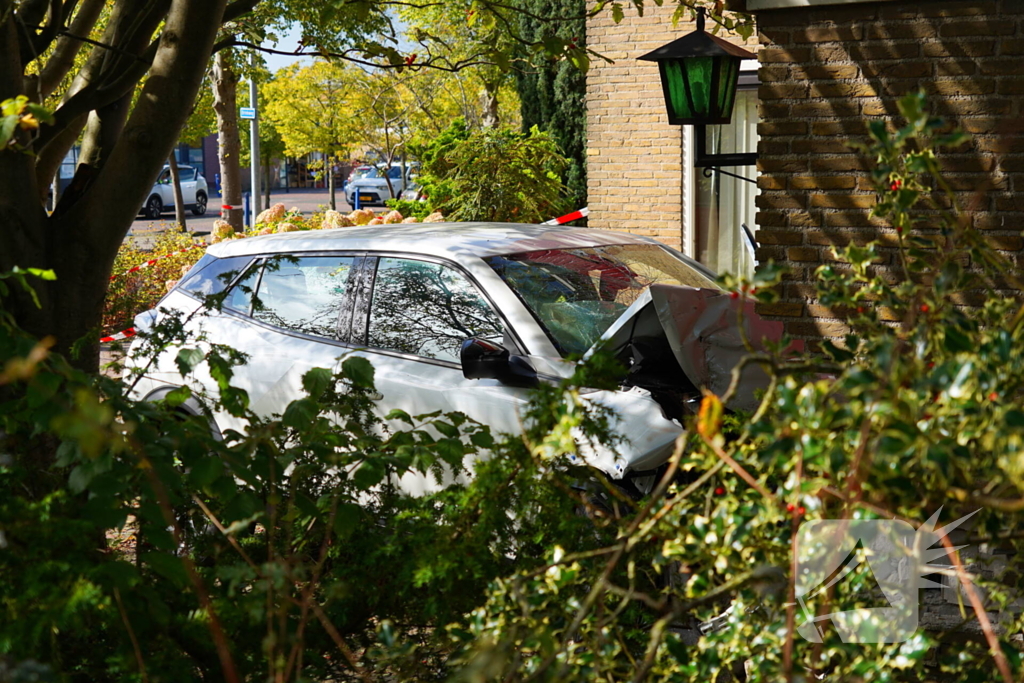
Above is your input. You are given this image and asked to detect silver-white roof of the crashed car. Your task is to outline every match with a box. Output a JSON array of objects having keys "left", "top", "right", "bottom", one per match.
[{"left": 202, "top": 222, "right": 679, "bottom": 259}]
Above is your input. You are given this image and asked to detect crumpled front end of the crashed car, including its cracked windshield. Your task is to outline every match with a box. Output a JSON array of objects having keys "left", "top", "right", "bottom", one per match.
[{"left": 485, "top": 237, "right": 781, "bottom": 489}]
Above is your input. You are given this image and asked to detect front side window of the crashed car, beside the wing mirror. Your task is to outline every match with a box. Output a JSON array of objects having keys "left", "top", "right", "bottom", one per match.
[{"left": 367, "top": 258, "right": 502, "bottom": 362}]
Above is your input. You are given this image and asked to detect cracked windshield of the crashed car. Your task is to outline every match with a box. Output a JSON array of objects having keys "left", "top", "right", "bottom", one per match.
[{"left": 486, "top": 245, "right": 717, "bottom": 355}]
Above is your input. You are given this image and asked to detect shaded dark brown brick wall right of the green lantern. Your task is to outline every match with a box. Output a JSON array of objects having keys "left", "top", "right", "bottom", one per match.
[{"left": 756, "top": 0, "right": 1024, "bottom": 337}]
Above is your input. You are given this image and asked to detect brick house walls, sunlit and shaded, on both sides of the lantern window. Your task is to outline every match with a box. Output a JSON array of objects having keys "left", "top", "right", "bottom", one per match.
[{"left": 588, "top": 0, "right": 1024, "bottom": 337}]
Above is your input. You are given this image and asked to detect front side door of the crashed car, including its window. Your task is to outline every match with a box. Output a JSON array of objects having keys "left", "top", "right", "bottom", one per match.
[{"left": 352, "top": 255, "right": 526, "bottom": 494}]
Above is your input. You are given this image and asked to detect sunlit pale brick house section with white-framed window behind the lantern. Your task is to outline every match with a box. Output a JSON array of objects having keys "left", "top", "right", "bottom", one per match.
[{"left": 587, "top": 3, "right": 757, "bottom": 278}]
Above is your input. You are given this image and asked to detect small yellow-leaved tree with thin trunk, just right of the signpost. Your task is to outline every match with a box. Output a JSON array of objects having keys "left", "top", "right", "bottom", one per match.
[{"left": 261, "top": 61, "right": 356, "bottom": 209}]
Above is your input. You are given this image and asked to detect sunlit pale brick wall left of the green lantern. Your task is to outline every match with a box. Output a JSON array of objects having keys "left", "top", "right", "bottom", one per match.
[{"left": 587, "top": 3, "right": 753, "bottom": 249}]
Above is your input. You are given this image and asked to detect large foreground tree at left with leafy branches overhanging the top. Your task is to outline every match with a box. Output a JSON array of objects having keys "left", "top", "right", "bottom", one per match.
[{"left": 0, "top": 0, "right": 745, "bottom": 385}]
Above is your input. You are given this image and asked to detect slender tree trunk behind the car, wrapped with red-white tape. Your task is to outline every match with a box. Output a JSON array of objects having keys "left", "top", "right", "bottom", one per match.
[{"left": 213, "top": 50, "right": 243, "bottom": 232}]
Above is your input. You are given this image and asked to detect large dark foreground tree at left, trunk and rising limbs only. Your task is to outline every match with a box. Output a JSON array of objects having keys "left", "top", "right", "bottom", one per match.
[{"left": 0, "top": 0, "right": 245, "bottom": 378}]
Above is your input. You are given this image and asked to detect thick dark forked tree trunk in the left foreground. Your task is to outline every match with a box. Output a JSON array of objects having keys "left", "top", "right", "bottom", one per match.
[{"left": 0, "top": 0, "right": 227, "bottom": 373}]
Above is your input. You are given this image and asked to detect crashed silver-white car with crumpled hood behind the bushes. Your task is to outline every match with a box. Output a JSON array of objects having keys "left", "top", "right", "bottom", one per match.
[{"left": 132, "top": 223, "right": 774, "bottom": 493}]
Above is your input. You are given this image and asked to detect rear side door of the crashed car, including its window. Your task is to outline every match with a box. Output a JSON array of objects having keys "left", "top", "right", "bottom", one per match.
[{"left": 209, "top": 253, "right": 361, "bottom": 432}]
